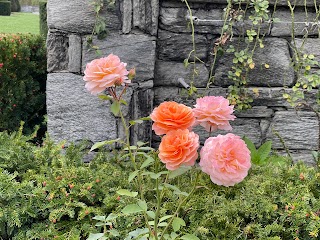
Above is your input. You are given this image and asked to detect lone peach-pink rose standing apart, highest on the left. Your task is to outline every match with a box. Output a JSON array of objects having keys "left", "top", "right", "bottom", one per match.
[{"left": 83, "top": 54, "right": 130, "bottom": 94}]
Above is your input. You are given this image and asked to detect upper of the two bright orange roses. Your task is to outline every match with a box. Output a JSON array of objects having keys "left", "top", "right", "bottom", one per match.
[{"left": 150, "top": 102, "right": 195, "bottom": 135}]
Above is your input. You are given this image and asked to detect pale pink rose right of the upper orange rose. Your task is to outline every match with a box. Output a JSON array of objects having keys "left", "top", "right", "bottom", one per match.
[{"left": 193, "top": 96, "right": 236, "bottom": 132}]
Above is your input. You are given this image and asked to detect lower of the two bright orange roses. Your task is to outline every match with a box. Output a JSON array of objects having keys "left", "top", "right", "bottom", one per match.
[{"left": 159, "top": 129, "right": 199, "bottom": 170}]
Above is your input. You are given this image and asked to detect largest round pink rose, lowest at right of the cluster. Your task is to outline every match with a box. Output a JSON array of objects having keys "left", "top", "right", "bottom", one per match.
[{"left": 199, "top": 133, "right": 251, "bottom": 187}]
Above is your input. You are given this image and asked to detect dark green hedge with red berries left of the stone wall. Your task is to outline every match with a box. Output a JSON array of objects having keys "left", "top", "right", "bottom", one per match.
[{"left": 0, "top": 34, "right": 46, "bottom": 137}]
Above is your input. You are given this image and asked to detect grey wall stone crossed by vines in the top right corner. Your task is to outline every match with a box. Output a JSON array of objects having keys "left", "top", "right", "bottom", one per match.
[{"left": 271, "top": 8, "right": 318, "bottom": 37}]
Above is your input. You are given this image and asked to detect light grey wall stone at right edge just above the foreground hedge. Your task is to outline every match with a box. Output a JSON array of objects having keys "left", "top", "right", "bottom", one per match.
[{"left": 267, "top": 111, "right": 319, "bottom": 150}]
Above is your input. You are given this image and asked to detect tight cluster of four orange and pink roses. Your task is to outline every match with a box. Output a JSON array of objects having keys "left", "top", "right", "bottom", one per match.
[{"left": 150, "top": 96, "right": 251, "bottom": 186}]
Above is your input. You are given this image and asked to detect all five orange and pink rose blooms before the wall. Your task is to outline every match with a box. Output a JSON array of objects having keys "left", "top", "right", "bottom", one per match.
[{"left": 83, "top": 54, "right": 251, "bottom": 186}]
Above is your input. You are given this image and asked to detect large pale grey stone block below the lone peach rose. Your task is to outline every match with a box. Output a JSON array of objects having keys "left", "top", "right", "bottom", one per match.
[{"left": 47, "top": 73, "right": 117, "bottom": 142}]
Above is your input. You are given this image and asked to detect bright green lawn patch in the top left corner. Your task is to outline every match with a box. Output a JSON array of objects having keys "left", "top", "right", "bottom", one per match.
[{"left": 0, "top": 12, "right": 40, "bottom": 34}]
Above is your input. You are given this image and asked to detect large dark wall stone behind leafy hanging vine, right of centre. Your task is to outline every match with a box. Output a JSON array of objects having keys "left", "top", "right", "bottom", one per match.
[{"left": 215, "top": 38, "right": 295, "bottom": 87}]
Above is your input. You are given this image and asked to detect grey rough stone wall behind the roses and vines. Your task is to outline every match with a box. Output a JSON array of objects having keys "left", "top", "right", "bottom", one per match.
[{"left": 47, "top": 0, "right": 320, "bottom": 162}]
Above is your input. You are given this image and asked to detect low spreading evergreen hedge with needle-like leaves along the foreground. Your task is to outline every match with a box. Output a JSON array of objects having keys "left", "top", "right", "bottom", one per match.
[{"left": 0, "top": 129, "right": 320, "bottom": 240}]
